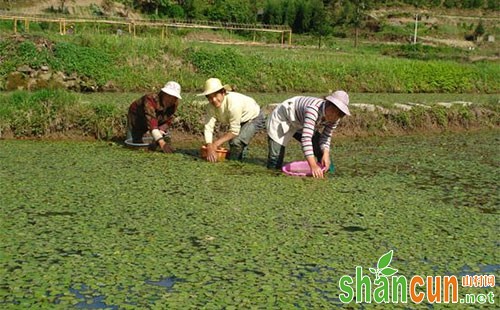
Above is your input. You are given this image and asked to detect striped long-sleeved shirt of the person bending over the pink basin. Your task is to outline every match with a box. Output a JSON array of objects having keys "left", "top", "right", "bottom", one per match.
[{"left": 292, "top": 96, "right": 338, "bottom": 157}]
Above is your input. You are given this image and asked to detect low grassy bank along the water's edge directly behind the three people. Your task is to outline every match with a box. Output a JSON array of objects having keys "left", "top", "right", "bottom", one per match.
[{"left": 0, "top": 90, "right": 500, "bottom": 140}]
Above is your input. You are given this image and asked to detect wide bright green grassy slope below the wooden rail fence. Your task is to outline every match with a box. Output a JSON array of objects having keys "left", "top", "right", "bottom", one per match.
[{"left": 0, "top": 32, "right": 500, "bottom": 93}]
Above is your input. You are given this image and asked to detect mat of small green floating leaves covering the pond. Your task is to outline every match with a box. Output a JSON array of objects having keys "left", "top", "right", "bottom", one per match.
[{"left": 0, "top": 131, "right": 500, "bottom": 309}]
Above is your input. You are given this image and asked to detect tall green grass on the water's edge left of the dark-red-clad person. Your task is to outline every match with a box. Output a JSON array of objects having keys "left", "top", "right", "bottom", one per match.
[{"left": 0, "top": 90, "right": 126, "bottom": 140}]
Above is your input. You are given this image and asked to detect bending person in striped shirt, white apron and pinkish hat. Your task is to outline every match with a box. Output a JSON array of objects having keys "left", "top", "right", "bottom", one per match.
[{"left": 267, "top": 90, "right": 351, "bottom": 178}]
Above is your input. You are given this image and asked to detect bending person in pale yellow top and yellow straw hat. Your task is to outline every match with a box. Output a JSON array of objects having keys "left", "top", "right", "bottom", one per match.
[{"left": 198, "top": 78, "right": 265, "bottom": 162}]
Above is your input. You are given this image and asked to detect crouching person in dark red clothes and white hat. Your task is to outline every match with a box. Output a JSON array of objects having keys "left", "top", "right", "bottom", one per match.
[{"left": 127, "top": 81, "right": 182, "bottom": 153}]
